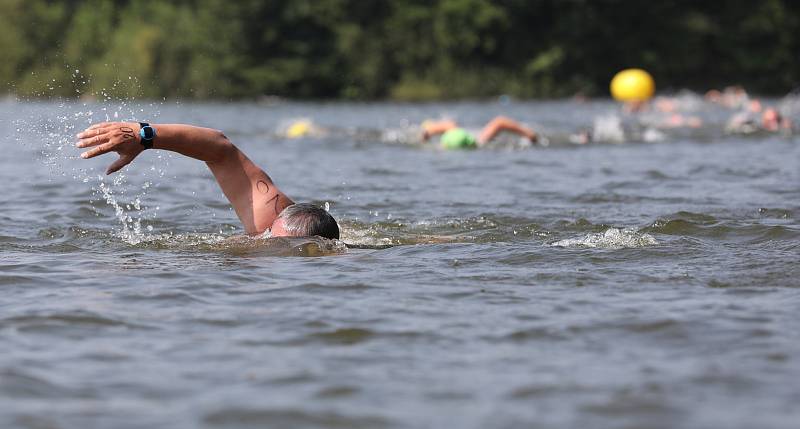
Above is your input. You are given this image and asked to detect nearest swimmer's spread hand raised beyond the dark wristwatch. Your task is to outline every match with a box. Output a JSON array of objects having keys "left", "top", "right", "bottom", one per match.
[{"left": 75, "top": 122, "right": 144, "bottom": 174}]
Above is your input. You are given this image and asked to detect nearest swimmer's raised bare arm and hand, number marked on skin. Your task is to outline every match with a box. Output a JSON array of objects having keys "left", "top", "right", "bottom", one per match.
[{"left": 76, "top": 122, "right": 293, "bottom": 234}]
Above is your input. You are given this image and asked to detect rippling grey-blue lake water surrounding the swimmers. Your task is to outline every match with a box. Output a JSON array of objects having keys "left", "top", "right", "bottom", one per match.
[{"left": 0, "top": 101, "right": 800, "bottom": 428}]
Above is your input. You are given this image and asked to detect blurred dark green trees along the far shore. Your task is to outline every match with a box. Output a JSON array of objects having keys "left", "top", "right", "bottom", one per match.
[{"left": 0, "top": 0, "right": 800, "bottom": 99}]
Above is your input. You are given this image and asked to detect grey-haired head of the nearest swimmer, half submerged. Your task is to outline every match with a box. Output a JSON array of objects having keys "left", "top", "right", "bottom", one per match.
[{"left": 271, "top": 203, "right": 339, "bottom": 240}]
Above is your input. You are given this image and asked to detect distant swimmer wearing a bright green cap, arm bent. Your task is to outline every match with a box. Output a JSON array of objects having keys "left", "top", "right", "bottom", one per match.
[{"left": 422, "top": 116, "right": 539, "bottom": 149}]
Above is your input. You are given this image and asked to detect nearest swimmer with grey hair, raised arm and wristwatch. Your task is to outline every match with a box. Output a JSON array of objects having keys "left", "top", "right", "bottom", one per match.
[{"left": 76, "top": 122, "right": 339, "bottom": 239}]
